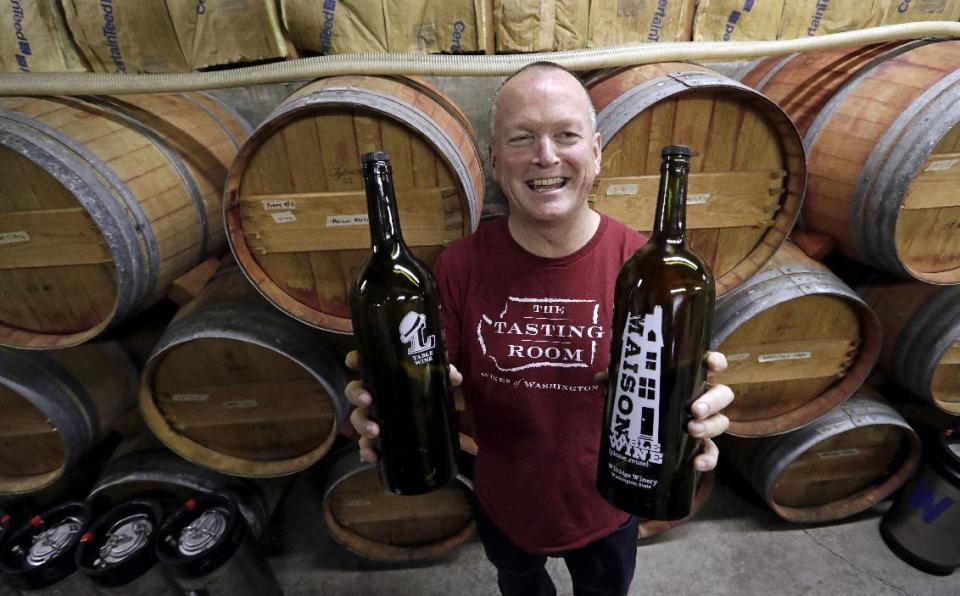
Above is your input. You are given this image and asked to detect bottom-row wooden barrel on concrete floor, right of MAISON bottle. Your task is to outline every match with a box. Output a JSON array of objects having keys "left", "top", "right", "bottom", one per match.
[{"left": 720, "top": 386, "right": 920, "bottom": 522}]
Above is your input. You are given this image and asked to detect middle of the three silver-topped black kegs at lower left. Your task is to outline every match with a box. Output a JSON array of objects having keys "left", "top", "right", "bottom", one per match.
[{"left": 76, "top": 499, "right": 179, "bottom": 596}]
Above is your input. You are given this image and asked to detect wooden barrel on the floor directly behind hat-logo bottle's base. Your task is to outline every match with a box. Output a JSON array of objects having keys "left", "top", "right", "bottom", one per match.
[{"left": 323, "top": 448, "right": 476, "bottom": 562}]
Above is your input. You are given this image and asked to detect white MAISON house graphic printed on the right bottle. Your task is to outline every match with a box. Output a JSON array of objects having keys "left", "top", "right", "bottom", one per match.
[{"left": 607, "top": 306, "right": 663, "bottom": 482}]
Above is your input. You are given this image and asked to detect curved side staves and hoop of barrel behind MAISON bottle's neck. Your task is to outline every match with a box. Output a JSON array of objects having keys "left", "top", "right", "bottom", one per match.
[{"left": 586, "top": 62, "right": 807, "bottom": 296}]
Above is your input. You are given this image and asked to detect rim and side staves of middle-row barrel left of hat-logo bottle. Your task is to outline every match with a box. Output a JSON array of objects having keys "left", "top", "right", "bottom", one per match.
[{"left": 139, "top": 265, "right": 349, "bottom": 478}]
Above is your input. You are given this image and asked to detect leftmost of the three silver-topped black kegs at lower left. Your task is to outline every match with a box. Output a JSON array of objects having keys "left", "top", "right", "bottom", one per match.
[{"left": 0, "top": 501, "right": 97, "bottom": 596}]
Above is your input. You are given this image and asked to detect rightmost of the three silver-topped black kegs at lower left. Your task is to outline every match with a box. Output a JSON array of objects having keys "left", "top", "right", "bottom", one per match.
[{"left": 157, "top": 493, "right": 283, "bottom": 596}]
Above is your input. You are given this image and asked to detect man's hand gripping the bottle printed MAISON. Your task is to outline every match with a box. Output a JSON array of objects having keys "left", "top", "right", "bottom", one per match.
[{"left": 595, "top": 352, "right": 733, "bottom": 472}]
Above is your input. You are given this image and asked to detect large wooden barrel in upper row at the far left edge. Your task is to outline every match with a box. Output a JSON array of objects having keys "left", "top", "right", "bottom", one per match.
[{"left": 0, "top": 93, "right": 247, "bottom": 348}]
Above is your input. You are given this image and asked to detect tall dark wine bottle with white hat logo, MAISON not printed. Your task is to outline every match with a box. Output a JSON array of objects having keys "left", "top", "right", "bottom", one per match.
[{"left": 350, "top": 151, "right": 457, "bottom": 495}]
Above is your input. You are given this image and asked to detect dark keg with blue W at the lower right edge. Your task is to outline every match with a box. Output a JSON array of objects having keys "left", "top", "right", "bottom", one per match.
[{"left": 880, "top": 421, "right": 960, "bottom": 575}]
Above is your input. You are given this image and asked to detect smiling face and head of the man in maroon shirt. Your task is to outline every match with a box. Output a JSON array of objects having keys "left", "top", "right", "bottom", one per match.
[{"left": 490, "top": 70, "right": 600, "bottom": 225}]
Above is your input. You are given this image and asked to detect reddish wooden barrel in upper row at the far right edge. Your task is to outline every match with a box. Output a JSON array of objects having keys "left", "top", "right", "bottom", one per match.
[{"left": 743, "top": 40, "right": 960, "bottom": 284}]
